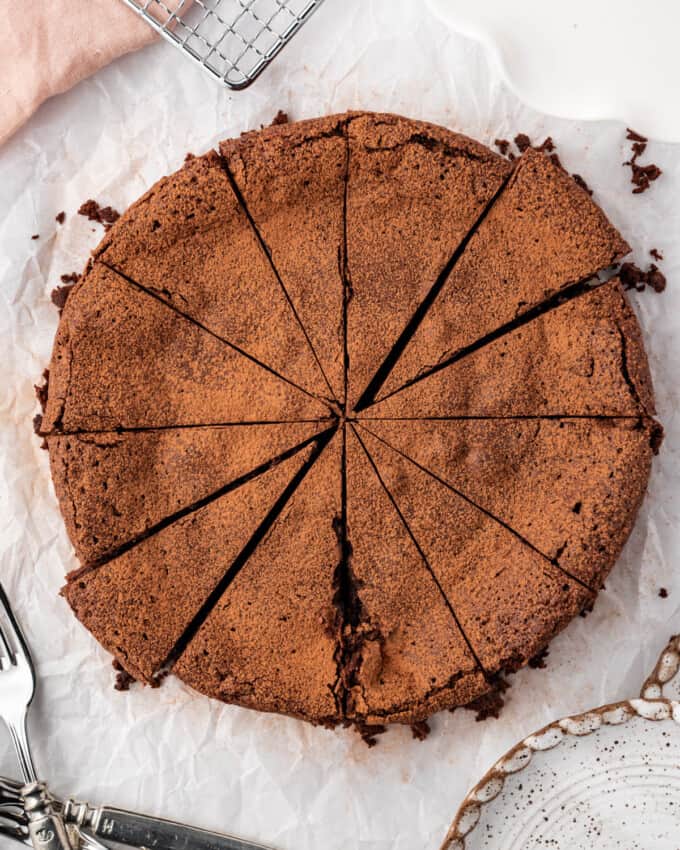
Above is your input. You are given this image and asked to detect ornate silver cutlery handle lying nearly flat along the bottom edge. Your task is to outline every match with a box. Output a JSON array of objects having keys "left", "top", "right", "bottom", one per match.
[{"left": 62, "top": 800, "right": 274, "bottom": 850}]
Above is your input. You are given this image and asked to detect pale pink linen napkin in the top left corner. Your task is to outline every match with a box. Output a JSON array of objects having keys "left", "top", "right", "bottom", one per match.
[{"left": 0, "top": 0, "right": 156, "bottom": 144}]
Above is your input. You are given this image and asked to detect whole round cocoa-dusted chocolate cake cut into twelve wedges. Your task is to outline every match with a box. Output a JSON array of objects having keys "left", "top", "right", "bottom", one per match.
[{"left": 35, "top": 113, "right": 660, "bottom": 737}]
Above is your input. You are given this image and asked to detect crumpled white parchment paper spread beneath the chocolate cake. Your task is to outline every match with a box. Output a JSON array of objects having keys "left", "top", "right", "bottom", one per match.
[{"left": 0, "top": 0, "right": 680, "bottom": 850}]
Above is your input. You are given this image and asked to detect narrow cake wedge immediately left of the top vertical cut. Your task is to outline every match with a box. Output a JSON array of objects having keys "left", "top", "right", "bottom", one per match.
[{"left": 220, "top": 115, "right": 347, "bottom": 401}]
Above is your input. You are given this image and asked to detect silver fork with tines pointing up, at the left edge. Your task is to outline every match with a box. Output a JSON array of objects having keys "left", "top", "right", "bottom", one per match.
[{"left": 0, "top": 584, "right": 71, "bottom": 850}]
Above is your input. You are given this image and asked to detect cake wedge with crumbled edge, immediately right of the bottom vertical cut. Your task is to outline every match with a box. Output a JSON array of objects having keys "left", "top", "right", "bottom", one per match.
[{"left": 343, "top": 429, "right": 489, "bottom": 725}]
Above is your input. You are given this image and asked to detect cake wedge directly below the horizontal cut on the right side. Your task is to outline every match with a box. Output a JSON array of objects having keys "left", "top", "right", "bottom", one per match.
[{"left": 366, "top": 419, "right": 654, "bottom": 590}]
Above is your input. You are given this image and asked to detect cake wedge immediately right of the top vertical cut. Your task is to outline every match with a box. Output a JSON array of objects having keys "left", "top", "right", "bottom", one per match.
[{"left": 347, "top": 114, "right": 511, "bottom": 410}]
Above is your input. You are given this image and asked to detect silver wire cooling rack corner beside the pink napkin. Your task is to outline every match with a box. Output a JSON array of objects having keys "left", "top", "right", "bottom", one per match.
[{"left": 125, "top": 0, "right": 323, "bottom": 89}]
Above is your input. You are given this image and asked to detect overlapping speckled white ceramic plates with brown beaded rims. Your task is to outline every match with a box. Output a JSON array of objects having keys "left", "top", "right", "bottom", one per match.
[{"left": 442, "top": 636, "right": 680, "bottom": 850}]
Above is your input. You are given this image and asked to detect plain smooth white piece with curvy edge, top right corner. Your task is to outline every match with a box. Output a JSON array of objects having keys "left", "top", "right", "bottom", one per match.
[{"left": 428, "top": 0, "right": 680, "bottom": 142}]
